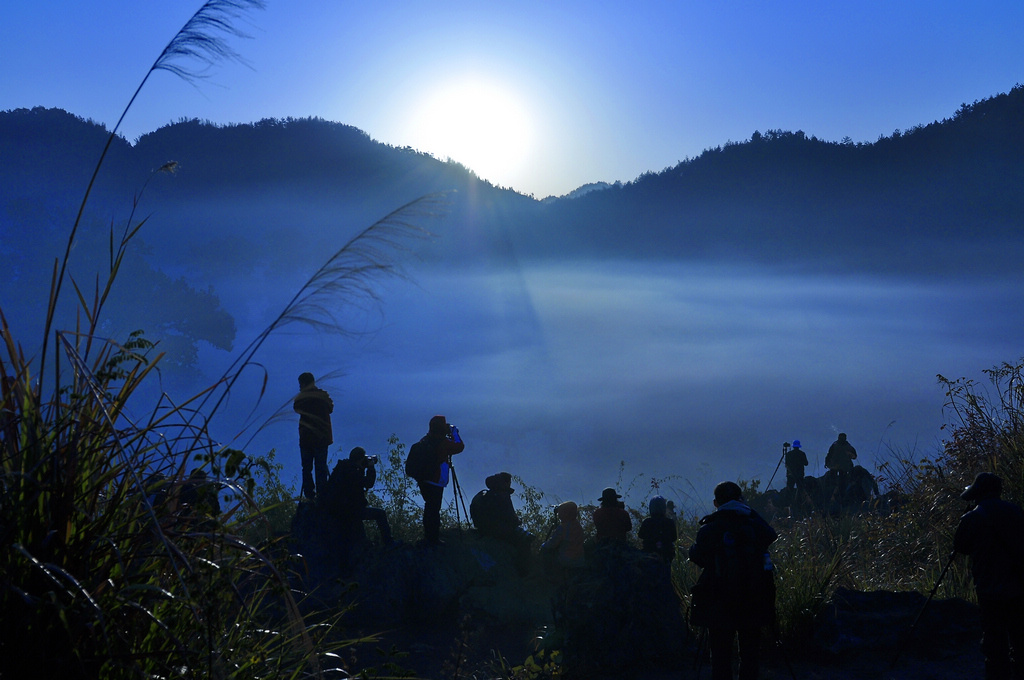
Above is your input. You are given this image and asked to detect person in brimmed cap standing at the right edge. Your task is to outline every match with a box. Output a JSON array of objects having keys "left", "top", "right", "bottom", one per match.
[{"left": 953, "top": 472, "right": 1024, "bottom": 680}]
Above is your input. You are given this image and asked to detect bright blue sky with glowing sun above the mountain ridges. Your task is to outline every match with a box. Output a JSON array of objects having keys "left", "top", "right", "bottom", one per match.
[{"left": 0, "top": 0, "right": 1024, "bottom": 198}]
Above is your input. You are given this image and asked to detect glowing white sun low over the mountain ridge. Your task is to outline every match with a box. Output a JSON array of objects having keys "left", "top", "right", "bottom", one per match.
[{"left": 412, "top": 78, "right": 534, "bottom": 184}]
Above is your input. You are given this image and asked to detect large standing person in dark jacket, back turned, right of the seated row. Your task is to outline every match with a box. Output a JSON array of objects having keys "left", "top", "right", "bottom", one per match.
[{"left": 688, "top": 481, "right": 778, "bottom": 680}]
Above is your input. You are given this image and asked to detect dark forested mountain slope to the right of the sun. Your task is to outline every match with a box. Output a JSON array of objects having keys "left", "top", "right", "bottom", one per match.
[{"left": 536, "top": 86, "right": 1024, "bottom": 271}]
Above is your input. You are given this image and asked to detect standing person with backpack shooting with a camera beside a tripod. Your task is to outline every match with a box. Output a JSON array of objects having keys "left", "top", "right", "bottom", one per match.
[{"left": 406, "top": 416, "right": 466, "bottom": 545}]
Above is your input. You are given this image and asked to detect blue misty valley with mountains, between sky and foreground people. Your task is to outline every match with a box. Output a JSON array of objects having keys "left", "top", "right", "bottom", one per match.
[{"left": 0, "top": 86, "right": 1024, "bottom": 506}]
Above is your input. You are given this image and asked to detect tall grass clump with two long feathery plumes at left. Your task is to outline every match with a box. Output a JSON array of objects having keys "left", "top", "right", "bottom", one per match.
[{"left": 0, "top": 0, "right": 437, "bottom": 678}]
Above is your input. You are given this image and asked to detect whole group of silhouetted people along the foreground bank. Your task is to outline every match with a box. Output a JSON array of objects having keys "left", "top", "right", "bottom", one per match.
[{"left": 294, "top": 373, "right": 1024, "bottom": 680}]
